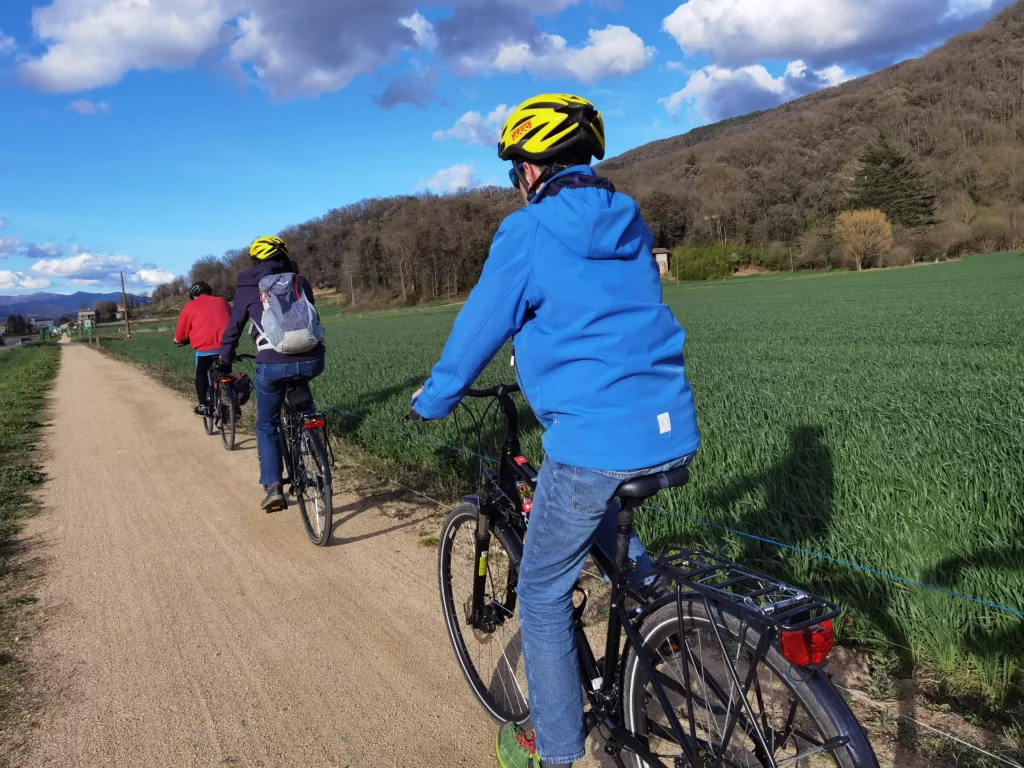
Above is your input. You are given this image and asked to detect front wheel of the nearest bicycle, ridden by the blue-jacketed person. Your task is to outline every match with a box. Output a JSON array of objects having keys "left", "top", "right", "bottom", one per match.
[{"left": 437, "top": 503, "right": 529, "bottom": 723}]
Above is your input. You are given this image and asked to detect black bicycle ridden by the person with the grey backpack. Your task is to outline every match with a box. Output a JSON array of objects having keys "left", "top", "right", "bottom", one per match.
[{"left": 268, "top": 378, "right": 334, "bottom": 547}]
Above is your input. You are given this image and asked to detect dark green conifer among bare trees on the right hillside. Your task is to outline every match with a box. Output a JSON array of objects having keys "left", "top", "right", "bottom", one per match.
[{"left": 850, "top": 136, "right": 935, "bottom": 229}]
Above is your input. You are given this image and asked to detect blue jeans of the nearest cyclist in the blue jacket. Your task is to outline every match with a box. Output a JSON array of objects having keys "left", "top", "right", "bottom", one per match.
[{"left": 518, "top": 456, "right": 693, "bottom": 765}]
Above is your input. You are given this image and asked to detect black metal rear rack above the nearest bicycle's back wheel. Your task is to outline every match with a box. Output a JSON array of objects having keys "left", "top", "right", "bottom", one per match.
[{"left": 654, "top": 547, "right": 840, "bottom": 630}]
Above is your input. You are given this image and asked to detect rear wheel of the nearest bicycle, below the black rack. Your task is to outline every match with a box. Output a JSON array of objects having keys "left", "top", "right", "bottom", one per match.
[{"left": 623, "top": 599, "right": 878, "bottom": 768}]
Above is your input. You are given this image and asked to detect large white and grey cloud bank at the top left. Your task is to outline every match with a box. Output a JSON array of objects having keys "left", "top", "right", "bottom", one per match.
[{"left": 19, "top": 0, "right": 438, "bottom": 98}]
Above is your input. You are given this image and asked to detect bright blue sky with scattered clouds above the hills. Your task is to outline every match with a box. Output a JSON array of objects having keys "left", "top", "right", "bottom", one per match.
[{"left": 0, "top": 0, "right": 1009, "bottom": 293}]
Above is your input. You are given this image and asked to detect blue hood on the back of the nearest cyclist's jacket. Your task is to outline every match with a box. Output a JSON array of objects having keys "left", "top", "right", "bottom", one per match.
[{"left": 525, "top": 165, "right": 652, "bottom": 259}]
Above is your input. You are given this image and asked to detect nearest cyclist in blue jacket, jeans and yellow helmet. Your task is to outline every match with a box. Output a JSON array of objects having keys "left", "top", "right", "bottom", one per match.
[{"left": 414, "top": 94, "right": 700, "bottom": 768}]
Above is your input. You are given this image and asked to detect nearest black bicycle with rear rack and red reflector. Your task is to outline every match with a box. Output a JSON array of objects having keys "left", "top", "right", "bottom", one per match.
[{"left": 428, "top": 384, "right": 878, "bottom": 768}]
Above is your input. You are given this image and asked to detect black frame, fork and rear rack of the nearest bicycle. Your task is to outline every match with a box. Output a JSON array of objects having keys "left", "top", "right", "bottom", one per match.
[{"left": 466, "top": 391, "right": 849, "bottom": 768}]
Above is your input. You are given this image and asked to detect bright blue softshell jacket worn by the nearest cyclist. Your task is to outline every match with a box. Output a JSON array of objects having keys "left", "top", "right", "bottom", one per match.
[{"left": 414, "top": 166, "right": 700, "bottom": 471}]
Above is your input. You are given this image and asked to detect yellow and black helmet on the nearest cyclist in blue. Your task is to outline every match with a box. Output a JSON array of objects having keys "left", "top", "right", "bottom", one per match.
[{"left": 498, "top": 93, "right": 604, "bottom": 164}]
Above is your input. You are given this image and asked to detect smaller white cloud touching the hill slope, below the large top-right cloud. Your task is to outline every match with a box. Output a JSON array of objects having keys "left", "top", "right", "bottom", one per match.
[{"left": 659, "top": 60, "right": 850, "bottom": 121}]
